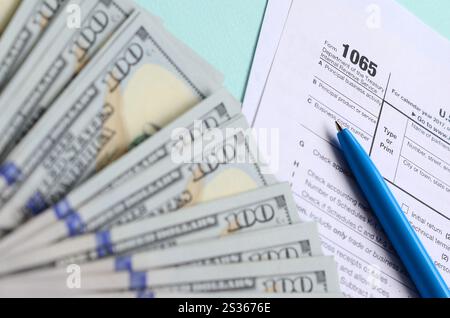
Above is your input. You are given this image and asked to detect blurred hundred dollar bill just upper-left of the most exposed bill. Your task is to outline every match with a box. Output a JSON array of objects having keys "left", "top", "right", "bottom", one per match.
[{"left": 0, "top": 0, "right": 135, "bottom": 157}]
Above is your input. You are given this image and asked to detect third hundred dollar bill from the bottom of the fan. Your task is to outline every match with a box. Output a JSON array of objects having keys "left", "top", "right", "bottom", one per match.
[{"left": 0, "top": 184, "right": 300, "bottom": 275}]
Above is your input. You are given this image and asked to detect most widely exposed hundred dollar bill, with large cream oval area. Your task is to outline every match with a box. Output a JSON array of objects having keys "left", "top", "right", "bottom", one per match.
[{"left": 0, "top": 12, "right": 220, "bottom": 228}]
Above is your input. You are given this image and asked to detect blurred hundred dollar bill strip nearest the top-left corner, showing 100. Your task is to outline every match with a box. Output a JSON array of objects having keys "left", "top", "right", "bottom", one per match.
[{"left": 0, "top": 0, "right": 68, "bottom": 89}]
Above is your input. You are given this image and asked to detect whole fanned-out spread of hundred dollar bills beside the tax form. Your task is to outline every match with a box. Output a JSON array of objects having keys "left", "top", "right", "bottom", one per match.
[{"left": 0, "top": 0, "right": 340, "bottom": 298}]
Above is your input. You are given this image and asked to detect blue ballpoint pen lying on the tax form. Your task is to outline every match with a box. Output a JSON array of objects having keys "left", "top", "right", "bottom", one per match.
[{"left": 336, "top": 122, "right": 450, "bottom": 298}]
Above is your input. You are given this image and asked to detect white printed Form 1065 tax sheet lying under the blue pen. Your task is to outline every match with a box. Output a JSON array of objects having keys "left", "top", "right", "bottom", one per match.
[{"left": 251, "top": 0, "right": 450, "bottom": 297}]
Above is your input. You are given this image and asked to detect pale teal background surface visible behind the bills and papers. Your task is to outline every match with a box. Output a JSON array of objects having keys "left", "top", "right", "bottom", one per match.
[{"left": 137, "top": 0, "right": 450, "bottom": 99}]
